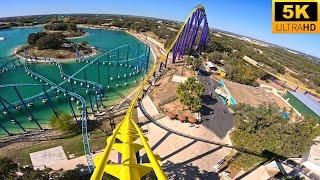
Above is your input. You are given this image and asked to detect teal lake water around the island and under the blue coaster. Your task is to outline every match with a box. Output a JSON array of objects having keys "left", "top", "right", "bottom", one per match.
[{"left": 0, "top": 27, "right": 154, "bottom": 136}]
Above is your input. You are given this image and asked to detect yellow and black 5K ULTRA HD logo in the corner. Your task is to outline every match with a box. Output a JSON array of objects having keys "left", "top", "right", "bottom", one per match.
[{"left": 272, "top": 0, "right": 320, "bottom": 33}]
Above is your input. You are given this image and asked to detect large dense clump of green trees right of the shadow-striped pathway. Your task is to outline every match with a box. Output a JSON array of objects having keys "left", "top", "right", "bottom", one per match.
[{"left": 230, "top": 104, "right": 320, "bottom": 170}]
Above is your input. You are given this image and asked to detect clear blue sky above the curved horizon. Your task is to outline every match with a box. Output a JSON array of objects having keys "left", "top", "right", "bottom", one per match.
[{"left": 0, "top": 0, "right": 320, "bottom": 57}]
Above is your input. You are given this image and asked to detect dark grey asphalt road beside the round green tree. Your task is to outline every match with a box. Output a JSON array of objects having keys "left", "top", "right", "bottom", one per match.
[{"left": 197, "top": 65, "right": 233, "bottom": 139}]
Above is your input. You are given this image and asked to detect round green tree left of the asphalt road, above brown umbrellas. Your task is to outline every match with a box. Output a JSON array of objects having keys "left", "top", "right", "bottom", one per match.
[{"left": 177, "top": 77, "right": 204, "bottom": 111}]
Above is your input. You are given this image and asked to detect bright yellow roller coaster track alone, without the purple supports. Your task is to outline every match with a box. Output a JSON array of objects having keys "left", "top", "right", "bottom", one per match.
[{"left": 91, "top": 5, "right": 205, "bottom": 180}]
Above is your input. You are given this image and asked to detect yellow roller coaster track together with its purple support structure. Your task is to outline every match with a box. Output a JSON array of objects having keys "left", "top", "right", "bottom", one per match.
[{"left": 91, "top": 5, "right": 209, "bottom": 180}]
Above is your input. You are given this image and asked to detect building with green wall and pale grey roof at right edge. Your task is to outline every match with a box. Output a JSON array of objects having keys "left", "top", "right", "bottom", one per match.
[{"left": 283, "top": 91, "right": 320, "bottom": 122}]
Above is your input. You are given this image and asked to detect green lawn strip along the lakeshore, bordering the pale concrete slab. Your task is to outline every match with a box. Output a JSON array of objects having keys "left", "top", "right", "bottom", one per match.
[{"left": 0, "top": 130, "right": 106, "bottom": 165}]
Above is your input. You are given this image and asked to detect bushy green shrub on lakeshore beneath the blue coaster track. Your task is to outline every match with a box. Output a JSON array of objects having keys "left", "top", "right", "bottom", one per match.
[{"left": 49, "top": 112, "right": 77, "bottom": 132}]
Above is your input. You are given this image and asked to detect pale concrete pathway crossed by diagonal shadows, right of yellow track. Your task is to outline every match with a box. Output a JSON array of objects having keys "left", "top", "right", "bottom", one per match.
[{"left": 139, "top": 96, "right": 231, "bottom": 179}]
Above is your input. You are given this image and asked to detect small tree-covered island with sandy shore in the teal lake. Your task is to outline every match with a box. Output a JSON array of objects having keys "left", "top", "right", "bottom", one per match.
[{"left": 14, "top": 23, "right": 96, "bottom": 60}]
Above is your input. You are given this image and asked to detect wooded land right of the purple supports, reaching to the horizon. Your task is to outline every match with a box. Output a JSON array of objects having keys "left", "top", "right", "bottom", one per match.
[{"left": 205, "top": 32, "right": 320, "bottom": 92}]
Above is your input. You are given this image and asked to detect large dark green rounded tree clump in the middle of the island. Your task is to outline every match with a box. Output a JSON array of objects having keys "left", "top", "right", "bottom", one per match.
[{"left": 36, "top": 33, "right": 68, "bottom": 50}]
